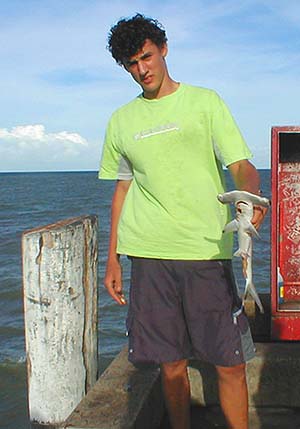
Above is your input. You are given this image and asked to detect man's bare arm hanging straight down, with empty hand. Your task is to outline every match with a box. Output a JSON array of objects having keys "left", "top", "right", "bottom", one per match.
[{"left": 104, "top": 180, "right": 131, "bottom": 305}]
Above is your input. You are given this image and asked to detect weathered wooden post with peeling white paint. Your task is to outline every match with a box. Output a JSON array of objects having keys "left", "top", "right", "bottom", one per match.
[{"left": 22, "top": 216, "right": 98, "bottom": 427}]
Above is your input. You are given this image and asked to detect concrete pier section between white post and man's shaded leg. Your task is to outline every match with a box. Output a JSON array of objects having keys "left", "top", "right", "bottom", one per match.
[{"left": 63, "top": 348, "right": 164, "bottom": 429}]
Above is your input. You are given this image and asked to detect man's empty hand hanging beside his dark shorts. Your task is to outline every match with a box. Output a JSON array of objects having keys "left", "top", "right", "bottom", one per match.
[{"left": 104, "top": 260, "right": 127, "bottom": 305}]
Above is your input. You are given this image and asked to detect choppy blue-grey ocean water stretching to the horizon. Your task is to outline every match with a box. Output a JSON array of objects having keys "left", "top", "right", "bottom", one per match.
[{"left": 0, "top": 170, "right": 270, "bottom": 429}]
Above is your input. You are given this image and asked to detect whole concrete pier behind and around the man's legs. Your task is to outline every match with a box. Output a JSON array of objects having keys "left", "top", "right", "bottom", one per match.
[{"left": 63, "top": 295, "right": 300, "bottom": 429}]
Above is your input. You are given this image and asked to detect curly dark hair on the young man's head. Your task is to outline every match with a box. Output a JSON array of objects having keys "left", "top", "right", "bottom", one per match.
[{"left": 107, "top": 13, "right": 168, "bottom": 65}]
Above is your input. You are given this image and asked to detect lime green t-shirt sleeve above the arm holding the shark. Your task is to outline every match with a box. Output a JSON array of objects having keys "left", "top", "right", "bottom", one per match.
[{"left": 212, "top": 93, "right": 252, "bottom": 166}]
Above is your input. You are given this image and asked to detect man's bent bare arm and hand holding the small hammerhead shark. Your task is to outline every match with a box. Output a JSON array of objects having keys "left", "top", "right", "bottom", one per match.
[{"left": 228, "top": 159, "right": 268, "bottom": 229}]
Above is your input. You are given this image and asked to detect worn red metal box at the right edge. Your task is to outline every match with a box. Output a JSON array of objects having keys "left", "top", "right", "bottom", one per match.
[{"left": 271, "top": 127, "right": 300, "bottom": 340}]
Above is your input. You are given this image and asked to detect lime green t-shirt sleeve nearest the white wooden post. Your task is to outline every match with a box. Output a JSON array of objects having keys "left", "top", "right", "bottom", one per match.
[{"left": 98, "top": 113, "right": 133, "bottom": 180}]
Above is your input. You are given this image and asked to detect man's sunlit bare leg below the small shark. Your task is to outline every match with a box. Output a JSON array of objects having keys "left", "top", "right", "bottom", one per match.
[{"left": 216, "top": 364, "right": 248, "bottom": 429}]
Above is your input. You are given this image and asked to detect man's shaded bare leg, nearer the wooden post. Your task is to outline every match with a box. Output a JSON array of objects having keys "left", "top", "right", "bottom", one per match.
[{"left": 160, "top": 360, "right": 191, "bottom": 429}]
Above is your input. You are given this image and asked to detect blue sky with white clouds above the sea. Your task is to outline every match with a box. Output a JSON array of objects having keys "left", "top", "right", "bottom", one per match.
[{"left": 0, "top": 0, "right": 300, "bottom": 172}]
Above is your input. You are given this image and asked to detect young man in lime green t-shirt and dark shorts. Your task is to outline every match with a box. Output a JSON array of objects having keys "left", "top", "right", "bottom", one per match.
[{"left": 99, "top": 14, "right": 265, "bottom": 429}]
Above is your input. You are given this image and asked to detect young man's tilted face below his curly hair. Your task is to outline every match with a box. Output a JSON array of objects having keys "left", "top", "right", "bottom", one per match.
[{"left": 124, "top": 39, "right": 168, "bottom": 98}]
